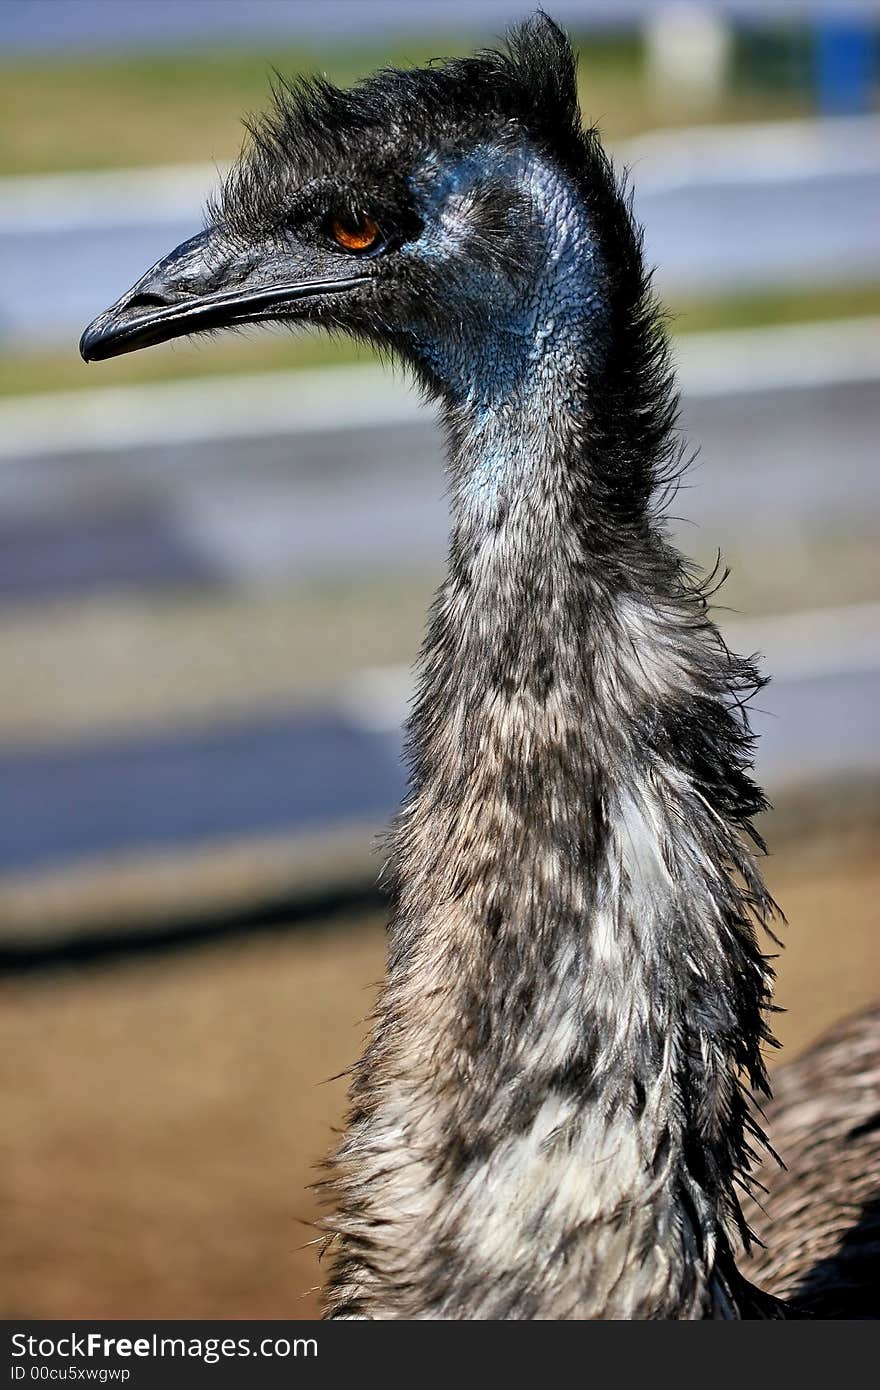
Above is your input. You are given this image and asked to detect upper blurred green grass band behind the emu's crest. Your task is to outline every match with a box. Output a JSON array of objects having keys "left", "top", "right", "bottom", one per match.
[{"left": 0, "top": 35, "right": 806, "bottom": 174}]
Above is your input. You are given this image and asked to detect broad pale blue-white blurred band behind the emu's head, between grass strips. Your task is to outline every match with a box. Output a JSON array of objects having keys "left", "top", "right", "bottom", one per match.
[{"left": 0, "top": 117, "right": 880, "bottom": 345}]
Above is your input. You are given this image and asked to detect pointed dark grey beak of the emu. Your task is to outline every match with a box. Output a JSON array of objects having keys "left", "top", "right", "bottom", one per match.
[{"left": 79, "top": 227, "right": 368, "bottom": 361}]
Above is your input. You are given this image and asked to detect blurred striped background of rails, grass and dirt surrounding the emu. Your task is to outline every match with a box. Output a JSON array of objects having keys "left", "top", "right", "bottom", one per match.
[{"left": 0, "top": 0, "right": 880, "bottom": 1318}]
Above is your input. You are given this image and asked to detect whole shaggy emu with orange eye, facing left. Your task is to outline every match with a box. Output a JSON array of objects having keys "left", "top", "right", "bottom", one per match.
[{"left": 81, "top": 15, "right": 879, "bottom": 1319}]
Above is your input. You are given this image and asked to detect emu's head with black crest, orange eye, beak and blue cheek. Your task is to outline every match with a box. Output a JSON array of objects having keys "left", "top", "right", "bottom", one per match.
[{"left": 81, "top": 15, "right": 602, "bottom": 396}]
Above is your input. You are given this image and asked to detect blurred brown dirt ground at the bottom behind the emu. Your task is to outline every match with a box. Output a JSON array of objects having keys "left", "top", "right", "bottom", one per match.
[{"left": 0, "top": 838, "right": 880, "bottom": 1318}]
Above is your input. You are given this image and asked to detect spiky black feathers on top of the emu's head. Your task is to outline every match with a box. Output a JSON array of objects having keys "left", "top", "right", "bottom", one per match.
[{"left": 213, "top": 14, "right": 580, "bottom": 238}]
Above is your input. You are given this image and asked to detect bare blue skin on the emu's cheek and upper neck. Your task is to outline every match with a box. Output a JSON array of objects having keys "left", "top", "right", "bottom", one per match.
[{"left": 413, "top": 145, "right": 603, "bottom": 516}]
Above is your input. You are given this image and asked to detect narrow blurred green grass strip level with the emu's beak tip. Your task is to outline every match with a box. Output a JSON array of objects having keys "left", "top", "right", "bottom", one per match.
[{"left": 0, "top": 285, "right": 880, "bottom": 396}]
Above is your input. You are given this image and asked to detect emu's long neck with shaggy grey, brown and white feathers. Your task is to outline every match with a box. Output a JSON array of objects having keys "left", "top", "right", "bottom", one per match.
[{"left": 331, "top": 201, "right": 767, "bottom": 1318}]
